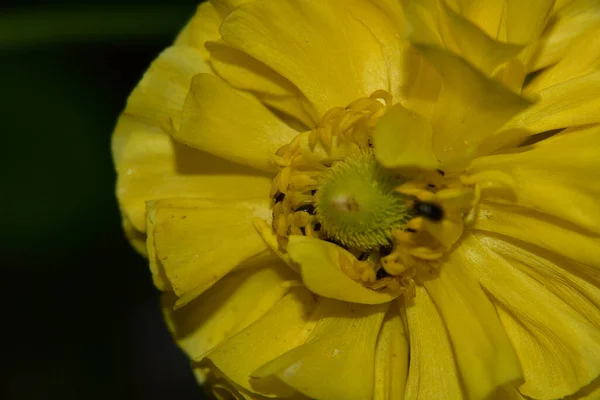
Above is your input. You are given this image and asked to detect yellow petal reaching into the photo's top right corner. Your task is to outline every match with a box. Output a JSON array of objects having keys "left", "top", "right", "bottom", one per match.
[{"left": 524, "top": 0, "right": 600, "bottom": 71}]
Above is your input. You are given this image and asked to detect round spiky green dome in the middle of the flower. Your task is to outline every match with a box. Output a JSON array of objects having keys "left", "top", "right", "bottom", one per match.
[{"left": 316, "top": 153, "right": 411, "bottom": 250}]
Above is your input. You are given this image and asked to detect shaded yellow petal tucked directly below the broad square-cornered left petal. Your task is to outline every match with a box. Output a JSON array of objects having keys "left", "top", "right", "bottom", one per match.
[{"left": 163, "top": 260, "right": 295, "bottom": 361}]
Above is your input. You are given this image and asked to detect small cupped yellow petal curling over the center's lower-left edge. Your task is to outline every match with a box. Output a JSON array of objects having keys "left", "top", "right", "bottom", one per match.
[{"left": 287, "top": 235, "right": 398, "bottom": 304}]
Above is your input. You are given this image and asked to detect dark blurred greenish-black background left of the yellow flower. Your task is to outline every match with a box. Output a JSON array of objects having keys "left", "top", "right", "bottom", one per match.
[{"left": 0, "top": 0, "right": 203, "bottom": 400}]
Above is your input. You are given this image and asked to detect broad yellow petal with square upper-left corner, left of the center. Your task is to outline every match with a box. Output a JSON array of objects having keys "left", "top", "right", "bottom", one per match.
[{"left": 148, "top": 199, "right": 269, "bottom": 306}]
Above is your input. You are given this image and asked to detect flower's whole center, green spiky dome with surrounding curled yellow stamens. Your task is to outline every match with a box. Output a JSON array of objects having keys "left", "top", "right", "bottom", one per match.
[{"left": 271, "top": 91, "right": 477, "bottom": 296}]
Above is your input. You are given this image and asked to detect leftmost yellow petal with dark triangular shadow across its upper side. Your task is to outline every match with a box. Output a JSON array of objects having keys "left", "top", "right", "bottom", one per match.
[{"left": 113, "top": 115, "right": 271, "bottom": 234}]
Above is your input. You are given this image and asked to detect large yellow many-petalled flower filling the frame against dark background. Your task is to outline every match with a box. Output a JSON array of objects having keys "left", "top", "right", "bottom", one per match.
[{"left": 113, "top": 0, "right": 600, "bottom": 400}]
